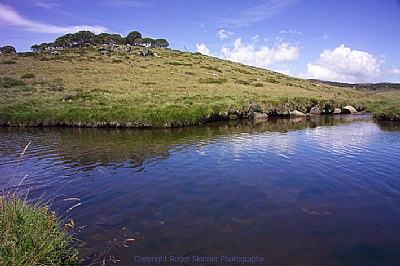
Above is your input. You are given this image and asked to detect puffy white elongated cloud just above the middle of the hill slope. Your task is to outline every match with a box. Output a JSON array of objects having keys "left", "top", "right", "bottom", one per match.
[{"left": 221, "top": 38, "right": 299, "bottom": 67}]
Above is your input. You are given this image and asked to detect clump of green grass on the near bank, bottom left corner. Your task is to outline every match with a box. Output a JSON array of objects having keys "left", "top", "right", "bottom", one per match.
[{"left": 0, "top": 194, "right": 80, "bottom": 266}]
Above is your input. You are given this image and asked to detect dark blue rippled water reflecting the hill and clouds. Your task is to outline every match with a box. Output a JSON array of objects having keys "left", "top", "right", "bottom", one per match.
[{"left": 0, "top": 116, "right": 400, "bottom": 265}]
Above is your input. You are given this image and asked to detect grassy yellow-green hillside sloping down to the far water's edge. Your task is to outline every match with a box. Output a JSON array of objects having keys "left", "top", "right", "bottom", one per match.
[{"left": 0, "top": 47, "right": 400, "bottom": 127}]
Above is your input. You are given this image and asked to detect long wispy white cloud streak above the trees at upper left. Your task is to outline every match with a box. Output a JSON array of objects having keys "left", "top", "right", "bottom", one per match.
[{"left": 0, "top": 4, "right": 108, "bottom": 34}]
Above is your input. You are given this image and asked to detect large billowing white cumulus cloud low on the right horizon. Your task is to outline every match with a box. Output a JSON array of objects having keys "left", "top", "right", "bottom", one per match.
[{"left": 300, "top": 44, "right": 384, "bottom": 83}]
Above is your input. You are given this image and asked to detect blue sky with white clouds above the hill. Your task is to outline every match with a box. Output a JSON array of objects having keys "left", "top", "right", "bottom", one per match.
[{"left": 0, "top": 0, "right": 400, "bottom": 82}]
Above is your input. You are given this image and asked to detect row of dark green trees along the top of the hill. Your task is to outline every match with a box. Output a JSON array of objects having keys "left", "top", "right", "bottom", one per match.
[{"left": 31, "top": 31, "right": 169, "bottom": 52}]
